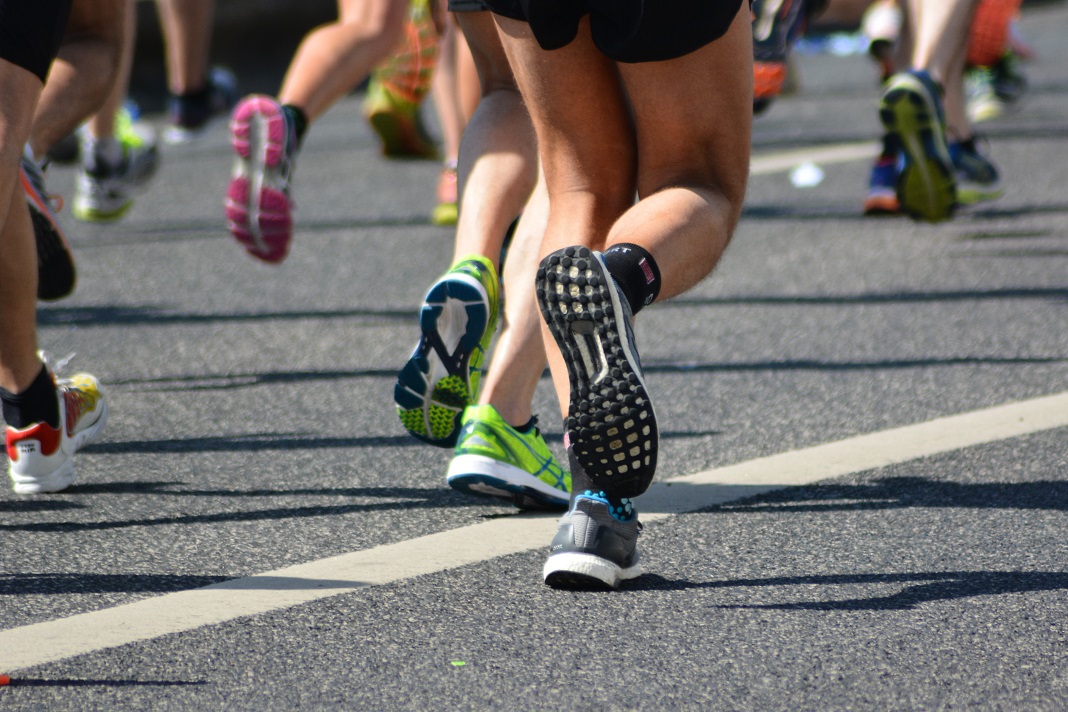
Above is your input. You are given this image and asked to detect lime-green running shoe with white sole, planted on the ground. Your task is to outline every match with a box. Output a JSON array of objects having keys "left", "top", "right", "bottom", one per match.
[{"left": 445, "top": 406, "right": 571, "bottom": 509}]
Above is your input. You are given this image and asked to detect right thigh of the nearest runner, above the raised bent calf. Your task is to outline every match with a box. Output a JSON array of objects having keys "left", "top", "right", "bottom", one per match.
[{"left": 619, "top": 5, "right": 753, "bottom": 205}]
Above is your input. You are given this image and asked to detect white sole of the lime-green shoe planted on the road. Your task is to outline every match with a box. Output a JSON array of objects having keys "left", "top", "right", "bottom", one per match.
[{"left": 445, "top": 455, "right": 570, "bottom": 510}]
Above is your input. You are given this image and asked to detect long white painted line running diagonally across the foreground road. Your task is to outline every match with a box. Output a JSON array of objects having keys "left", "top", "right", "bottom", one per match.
[{"left": 0, "top": 392, "right": 1068, "bottom": 673}]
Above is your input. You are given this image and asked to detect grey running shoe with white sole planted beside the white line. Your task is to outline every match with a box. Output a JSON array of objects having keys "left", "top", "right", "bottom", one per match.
[{"left": 541, "top": 484, "right": 642, "bottom": 589}]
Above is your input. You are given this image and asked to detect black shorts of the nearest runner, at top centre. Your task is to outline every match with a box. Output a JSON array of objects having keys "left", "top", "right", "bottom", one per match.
[{"left": 457, "top": 0, "right": 743, "bottom": 62}]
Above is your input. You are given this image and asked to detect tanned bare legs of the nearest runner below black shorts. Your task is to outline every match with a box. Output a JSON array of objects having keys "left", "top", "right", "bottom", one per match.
[{"left": 497, "top": 9, "right": 753, "bottom": 418}]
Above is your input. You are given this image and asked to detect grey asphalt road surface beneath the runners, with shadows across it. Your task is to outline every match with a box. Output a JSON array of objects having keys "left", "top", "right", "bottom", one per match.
[{"left": 0, "top": 3, "right": 1068, "bottom": 710}]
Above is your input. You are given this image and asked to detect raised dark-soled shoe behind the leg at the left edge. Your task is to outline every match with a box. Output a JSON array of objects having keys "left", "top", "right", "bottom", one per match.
[{"left": 18, "top": 154, "right": 78, "bottom": 301}]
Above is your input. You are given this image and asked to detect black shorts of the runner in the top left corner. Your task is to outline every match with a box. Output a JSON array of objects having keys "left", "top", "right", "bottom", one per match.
[{"left": 0, "top": 0, "right": 70, "bottom": 82}]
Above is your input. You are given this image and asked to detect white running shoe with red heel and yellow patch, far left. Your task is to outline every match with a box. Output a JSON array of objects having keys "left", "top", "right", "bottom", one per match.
[{"left": 6, "top": 374, "right": 108, "bottom": 494}]
